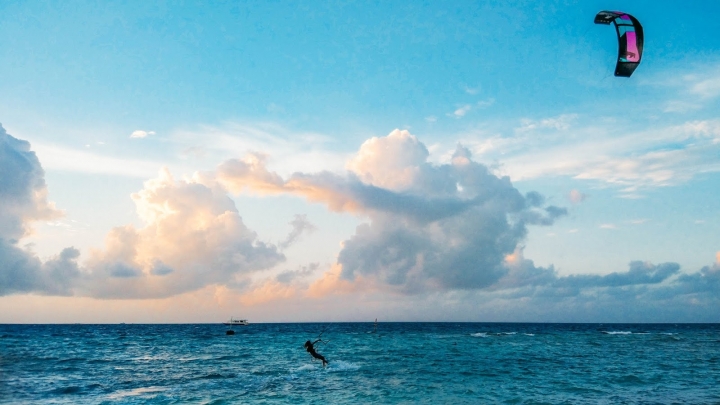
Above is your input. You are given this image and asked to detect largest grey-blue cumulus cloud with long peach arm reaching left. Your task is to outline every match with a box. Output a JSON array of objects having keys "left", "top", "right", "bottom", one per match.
[{"left": 217, "top": 130, "right": 567, "bottom": 293}]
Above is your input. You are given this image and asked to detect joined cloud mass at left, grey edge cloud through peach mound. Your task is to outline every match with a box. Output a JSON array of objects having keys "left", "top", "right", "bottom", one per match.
[{"left": 0, "top": 127, "right": 286, "bottom": 298}]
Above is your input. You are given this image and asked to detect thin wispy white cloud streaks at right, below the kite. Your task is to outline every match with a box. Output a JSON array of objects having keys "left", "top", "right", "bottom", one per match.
[{"left": 456, "top": 114, "right": 720, "bottom": 198}]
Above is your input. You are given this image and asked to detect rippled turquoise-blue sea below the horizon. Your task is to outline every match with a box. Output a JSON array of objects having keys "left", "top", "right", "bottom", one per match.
[{"left": 0, "top": 323, "right": 720, "bottom": 404}]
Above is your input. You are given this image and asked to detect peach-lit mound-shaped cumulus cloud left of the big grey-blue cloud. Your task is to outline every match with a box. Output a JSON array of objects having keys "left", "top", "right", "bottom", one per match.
[{"left": 78, "top": 169, "right": 284, "bottom": 298}]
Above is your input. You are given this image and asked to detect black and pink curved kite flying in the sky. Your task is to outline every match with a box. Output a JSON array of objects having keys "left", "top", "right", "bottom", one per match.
[{"left": 595, "top": 11, "right": 644, "bottom": 77}]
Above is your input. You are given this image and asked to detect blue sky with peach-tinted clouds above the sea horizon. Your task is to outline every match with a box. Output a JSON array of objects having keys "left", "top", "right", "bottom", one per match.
[{"left": 0, "top": 0, "right": 720, "bottom": 323}]
